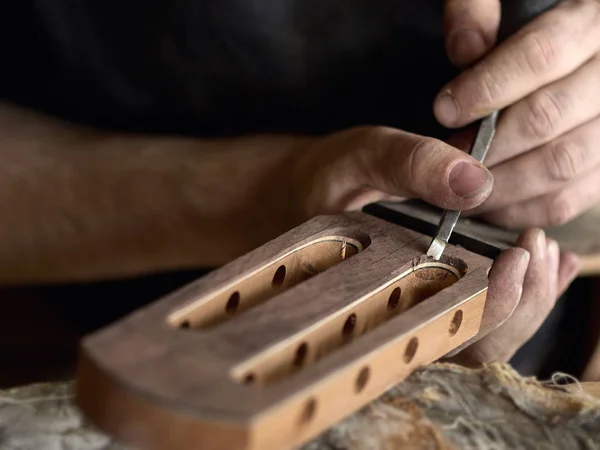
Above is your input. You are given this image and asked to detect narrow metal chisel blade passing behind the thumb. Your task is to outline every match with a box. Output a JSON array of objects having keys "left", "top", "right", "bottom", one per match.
[{"left": 427, "top": 111, "right": 499, "bottom": 260}]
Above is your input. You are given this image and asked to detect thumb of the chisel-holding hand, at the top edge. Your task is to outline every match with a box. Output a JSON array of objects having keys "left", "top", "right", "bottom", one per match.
[{"left": 444, "top": 0, "right": 500, "bottom": 68}]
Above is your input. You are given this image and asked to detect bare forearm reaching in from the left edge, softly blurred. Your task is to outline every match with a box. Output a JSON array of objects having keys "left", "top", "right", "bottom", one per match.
[{"left": 0, "top": 105, "right": 302, "bottom": 284}]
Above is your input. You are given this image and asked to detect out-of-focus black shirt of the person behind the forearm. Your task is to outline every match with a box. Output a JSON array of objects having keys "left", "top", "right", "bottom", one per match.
[{"left": 0, "top": 0, "right": 455, "bottom": 136}]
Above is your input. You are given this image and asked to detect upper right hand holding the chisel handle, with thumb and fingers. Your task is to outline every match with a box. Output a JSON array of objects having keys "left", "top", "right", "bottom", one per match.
[{"left": 434, "top": 0, "right": 600, "bottom": 228}]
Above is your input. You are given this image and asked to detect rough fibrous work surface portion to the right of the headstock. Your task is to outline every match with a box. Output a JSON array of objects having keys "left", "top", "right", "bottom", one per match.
[{"left": 306, "top": 365, "right": 600, "bottom": 450}]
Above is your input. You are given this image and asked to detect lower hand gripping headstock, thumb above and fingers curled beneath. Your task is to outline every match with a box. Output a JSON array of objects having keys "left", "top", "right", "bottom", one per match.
[{"left": 287, "top": 127, "right": 578, "bottom": 365}]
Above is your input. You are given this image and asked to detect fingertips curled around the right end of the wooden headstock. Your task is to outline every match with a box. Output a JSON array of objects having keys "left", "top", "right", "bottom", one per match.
[{"left": 447, "top": 229, "right": 579, "bottom": 366}]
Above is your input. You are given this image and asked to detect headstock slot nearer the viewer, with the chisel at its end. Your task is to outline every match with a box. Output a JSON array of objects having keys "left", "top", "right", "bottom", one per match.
[{"left": 232, "top": 258, "right": 467, "bottom": 388}]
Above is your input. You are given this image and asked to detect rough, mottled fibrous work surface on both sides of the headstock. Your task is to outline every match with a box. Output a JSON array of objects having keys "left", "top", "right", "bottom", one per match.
[{"left": 0, "top": 364, "right": 600, "bottom": 450}]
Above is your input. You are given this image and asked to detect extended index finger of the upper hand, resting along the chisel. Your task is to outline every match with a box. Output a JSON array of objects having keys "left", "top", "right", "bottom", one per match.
[{"left": 434, "top": 0, "right": 600, "bottom": 128}]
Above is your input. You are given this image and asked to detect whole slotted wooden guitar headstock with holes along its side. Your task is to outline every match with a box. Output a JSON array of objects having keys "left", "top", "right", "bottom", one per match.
[{"left": 77, "top": 213, "right": 492, "bottom": 450}]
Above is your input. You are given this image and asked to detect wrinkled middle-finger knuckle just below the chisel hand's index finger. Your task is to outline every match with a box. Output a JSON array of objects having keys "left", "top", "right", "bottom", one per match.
[{"left": 519, "top": 90, "right": 563, "bottom": 140}]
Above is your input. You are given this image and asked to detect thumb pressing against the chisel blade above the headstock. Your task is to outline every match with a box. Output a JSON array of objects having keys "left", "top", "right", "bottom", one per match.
[{"left": 305, "top": 127, "right": 493, "bottom": 213}]
